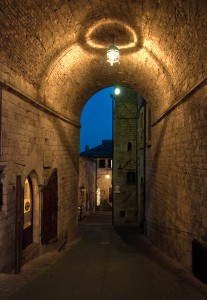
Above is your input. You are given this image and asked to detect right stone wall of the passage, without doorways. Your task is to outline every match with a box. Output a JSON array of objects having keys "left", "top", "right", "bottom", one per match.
[{"left": 146, "top": 84, "right": 207, "bottom": 269}]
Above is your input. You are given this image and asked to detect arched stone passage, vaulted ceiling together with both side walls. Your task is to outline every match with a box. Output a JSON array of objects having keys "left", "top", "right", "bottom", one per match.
[{"left": 0, "top": 0, "right": 207, "bottom": 276}]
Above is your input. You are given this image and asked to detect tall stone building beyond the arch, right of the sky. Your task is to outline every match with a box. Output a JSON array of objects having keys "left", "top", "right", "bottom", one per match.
[{"left": 113, "top": 88, "right": 146, "bottom": 227}]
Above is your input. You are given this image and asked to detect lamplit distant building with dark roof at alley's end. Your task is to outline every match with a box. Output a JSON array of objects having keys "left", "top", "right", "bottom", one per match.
[{"left": 80, "top": 140, "right": 113, "bottom": 208}]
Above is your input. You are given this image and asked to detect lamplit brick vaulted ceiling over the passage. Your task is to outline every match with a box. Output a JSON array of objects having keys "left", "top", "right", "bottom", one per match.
[{"left": 0, "top": 0, "right": 207, "bottom": 120}]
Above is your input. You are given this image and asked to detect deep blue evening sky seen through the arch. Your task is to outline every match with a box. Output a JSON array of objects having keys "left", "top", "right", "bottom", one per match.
[{"left": 80, "top": 87, "right": 114, "bottom": 152}]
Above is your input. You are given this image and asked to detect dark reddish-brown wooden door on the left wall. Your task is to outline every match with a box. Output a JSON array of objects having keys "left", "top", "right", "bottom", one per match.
[{"left": 41, "top": 170, "right": 58, "bottom": 245}]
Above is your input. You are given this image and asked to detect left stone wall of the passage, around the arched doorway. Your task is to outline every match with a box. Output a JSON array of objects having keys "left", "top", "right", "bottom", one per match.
[{"left": 0, "top": 78, "right": 79, "bottom": 272}]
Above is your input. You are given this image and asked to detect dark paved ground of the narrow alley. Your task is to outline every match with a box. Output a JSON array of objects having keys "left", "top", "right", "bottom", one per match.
[{"left": 0, "top": 212, "right": 207, "bottom": 300}]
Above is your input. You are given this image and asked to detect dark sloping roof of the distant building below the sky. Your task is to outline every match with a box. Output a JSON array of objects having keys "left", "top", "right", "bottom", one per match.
[{"left": 80, "top": 140, "right": 113, "bottom": 158}]
